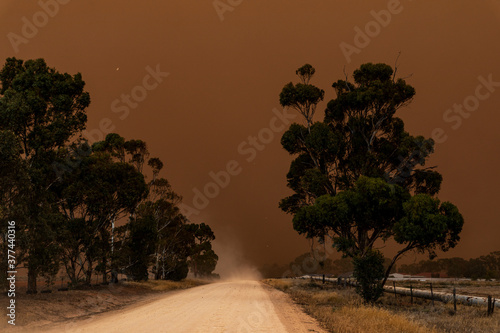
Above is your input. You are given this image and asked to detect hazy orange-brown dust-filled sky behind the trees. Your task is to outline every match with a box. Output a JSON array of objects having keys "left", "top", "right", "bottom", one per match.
[{"left": 0, "top": 0, "right": 500, "bottom": 265}]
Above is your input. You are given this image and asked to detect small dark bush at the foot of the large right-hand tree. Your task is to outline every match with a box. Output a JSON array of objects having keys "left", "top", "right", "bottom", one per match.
[{"left": 353, "top": 249, "right": 385, "bottom": 303}]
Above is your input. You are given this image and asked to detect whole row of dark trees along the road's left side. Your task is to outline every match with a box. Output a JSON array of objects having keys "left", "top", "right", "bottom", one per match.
[{"left": 0, "top": 58, "right": 218, "bottom": 293}]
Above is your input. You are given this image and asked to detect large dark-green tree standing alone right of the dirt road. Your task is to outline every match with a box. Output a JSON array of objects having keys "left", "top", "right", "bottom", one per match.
[{"left": 280, "top": 63, "right": 463, "bottom": 301}]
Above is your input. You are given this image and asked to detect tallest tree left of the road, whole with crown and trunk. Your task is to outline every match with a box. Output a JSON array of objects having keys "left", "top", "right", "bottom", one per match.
[{"left": 0, "top": 58, "right": 90, "bottom": 293}]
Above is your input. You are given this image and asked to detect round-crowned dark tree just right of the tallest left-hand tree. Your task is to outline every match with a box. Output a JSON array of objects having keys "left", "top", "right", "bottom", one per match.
[{"left": 57, "top": 143, "right": 147, "bottom": 284}]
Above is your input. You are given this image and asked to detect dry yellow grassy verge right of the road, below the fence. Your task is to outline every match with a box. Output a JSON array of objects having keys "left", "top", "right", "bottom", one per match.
[{"left": 264, "top": 279, "right": 500, "bottom": 333}]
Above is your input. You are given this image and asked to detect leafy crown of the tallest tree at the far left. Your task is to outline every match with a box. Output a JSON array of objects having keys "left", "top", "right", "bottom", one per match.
[{"left": 0, "top": 58, "right": 90, "bottom": 156}]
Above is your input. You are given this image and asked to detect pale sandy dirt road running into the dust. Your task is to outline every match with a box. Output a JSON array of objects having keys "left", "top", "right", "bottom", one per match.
[{"left": 42, "top": 281, "right": 326, "bottom": 333}]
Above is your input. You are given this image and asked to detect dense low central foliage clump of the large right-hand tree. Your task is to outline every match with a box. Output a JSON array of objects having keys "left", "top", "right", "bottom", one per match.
[{"left": 293, "top": 176, "right": 410, "bottom": 257}]
